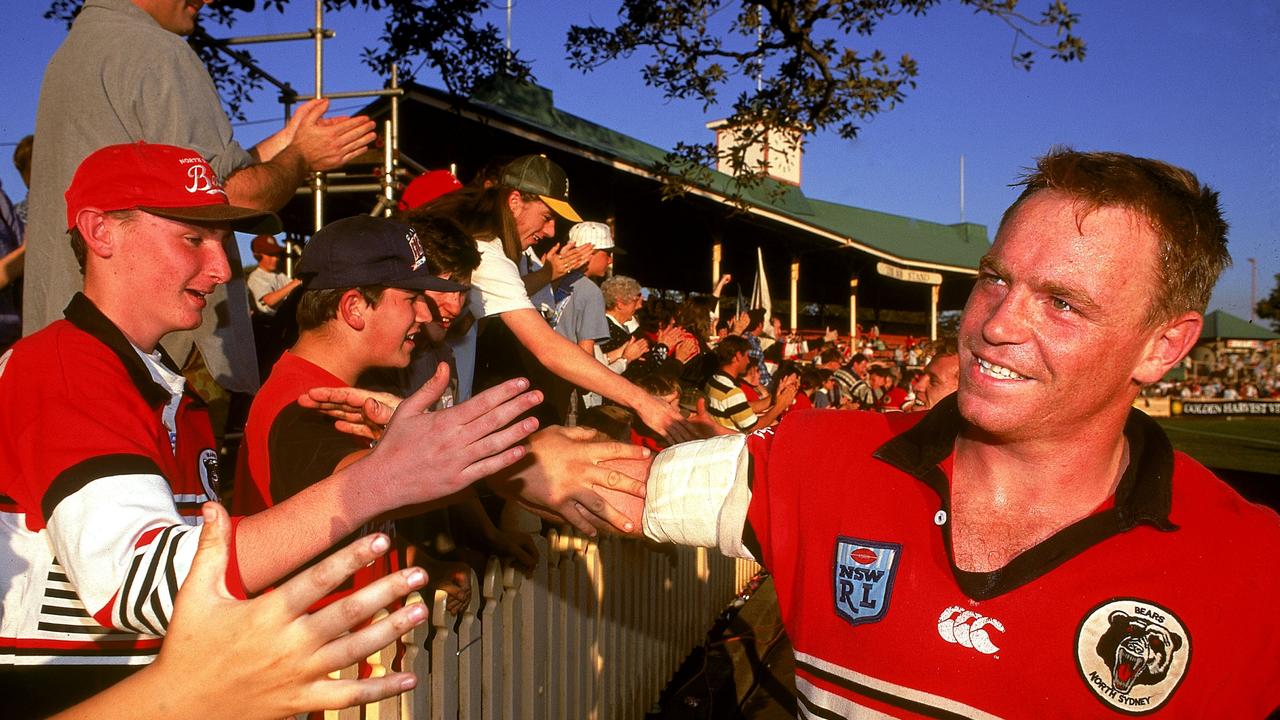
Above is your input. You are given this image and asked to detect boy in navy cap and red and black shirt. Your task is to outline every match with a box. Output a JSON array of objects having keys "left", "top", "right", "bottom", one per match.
[{"left": 237, "top": 215, "right": 480, "bottom": 510}]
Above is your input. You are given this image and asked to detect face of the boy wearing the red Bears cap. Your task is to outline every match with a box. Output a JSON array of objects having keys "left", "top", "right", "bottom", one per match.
[{"left": 104, "top": 211, "right": 232, "bottom": 351}]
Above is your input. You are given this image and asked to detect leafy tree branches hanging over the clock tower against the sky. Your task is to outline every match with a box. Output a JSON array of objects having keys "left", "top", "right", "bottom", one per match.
[{"left": 564, "top": 0, "right": 1085, "bottom": 198}]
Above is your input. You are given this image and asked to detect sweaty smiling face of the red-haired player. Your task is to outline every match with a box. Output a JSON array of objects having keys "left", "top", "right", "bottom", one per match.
[{"left": 957, "top": 191, "right": 1158, "bottom": 439}]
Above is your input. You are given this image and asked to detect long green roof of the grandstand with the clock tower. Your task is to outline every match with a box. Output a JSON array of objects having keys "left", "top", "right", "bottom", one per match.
[{"left": 471, "top": 78, "right": 991, "bottom": 269}]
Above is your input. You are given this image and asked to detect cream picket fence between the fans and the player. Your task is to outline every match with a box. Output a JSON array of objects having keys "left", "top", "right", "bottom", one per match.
[{"left": 325, "top": 530, "right": 759, "bottom": 720}]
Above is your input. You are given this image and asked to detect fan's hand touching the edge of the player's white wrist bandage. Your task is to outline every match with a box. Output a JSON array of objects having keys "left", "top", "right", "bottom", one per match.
[{"left": 488, "top": 427, "right": 649, "bottom": 536}]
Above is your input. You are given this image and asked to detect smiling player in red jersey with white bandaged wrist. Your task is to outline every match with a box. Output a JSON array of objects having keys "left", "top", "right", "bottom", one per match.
[{"left": 604, "top": 151, "right": 1280, "bottom": 717}]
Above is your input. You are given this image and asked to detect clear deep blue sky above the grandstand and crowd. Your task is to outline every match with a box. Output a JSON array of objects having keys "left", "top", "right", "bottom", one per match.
[{"left": 0, "top": 0, "right": 1280, "bottom": 318}]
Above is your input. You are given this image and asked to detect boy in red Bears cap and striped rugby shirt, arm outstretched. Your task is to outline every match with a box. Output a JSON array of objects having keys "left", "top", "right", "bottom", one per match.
[{"left": 0, "top": 142, "right": 552, "bottom": 716}]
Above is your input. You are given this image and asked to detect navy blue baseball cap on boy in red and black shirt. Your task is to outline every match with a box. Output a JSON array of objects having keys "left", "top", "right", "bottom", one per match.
[{"left": 298, "top": 215, "right": 468, "bottom": 292}]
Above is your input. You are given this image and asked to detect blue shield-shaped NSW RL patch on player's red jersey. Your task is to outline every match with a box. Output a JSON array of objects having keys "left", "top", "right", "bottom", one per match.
[{"left": 835, "top": 536, "right": 902, "bottom": 625}]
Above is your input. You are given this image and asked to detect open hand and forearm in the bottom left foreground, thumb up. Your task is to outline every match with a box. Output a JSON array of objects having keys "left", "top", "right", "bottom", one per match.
[{"left": 55, "top": 502, "right": 426, "bottom": 720}]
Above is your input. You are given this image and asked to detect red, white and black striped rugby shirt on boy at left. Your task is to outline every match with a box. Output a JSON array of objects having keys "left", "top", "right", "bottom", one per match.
[{"left": 0, "top": 295, "right": 243, "bottom": 665}]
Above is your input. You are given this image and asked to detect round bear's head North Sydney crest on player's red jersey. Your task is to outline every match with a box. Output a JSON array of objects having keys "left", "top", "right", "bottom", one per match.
[{"left": 1075, "top": 600, "right": 1192, "bottom": 715}]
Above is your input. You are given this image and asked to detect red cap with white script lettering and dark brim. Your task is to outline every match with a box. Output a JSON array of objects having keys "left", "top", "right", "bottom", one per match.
[{"left": 67, "top": 141, "right": 280, "bottom": 234}]
